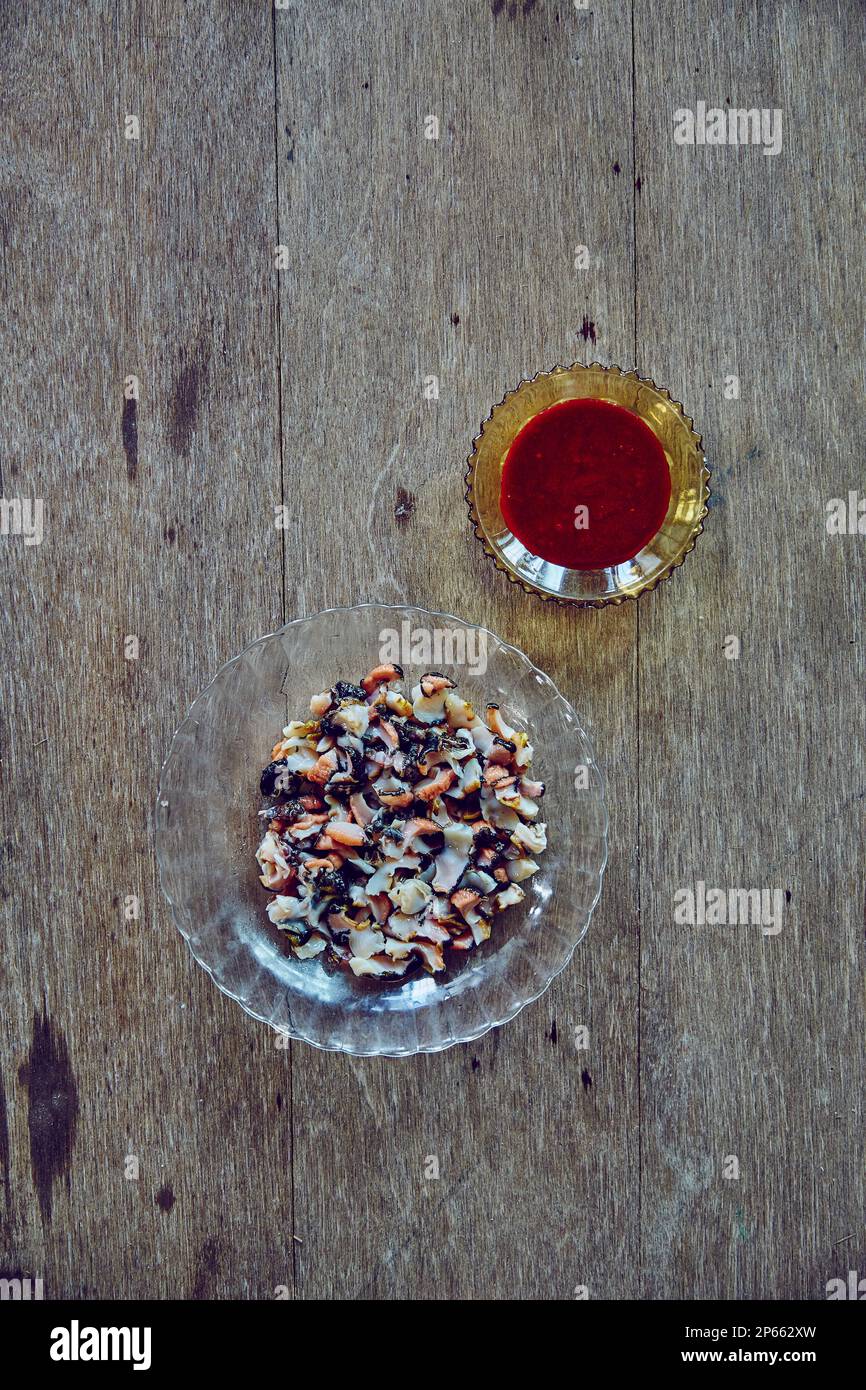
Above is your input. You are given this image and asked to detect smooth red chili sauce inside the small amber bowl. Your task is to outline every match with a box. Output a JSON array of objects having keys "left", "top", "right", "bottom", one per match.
[{"left": 499, "top": 400, "right": 670, "bottom": 570}]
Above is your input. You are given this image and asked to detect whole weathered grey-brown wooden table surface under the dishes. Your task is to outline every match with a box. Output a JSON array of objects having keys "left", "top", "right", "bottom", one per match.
[{"left": 0, "top": 0, "right": 866, "bottom": 1300}]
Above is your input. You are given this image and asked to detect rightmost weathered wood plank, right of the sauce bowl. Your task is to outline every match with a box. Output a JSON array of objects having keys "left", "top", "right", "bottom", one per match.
[{"left": 635, "top": 4, "right": 866, "bottom": 1298}]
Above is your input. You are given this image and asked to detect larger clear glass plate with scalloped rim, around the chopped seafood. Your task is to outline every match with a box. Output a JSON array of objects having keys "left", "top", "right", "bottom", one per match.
[{"left": 156, "top": 603, "right": 607, "bottom": 1056}]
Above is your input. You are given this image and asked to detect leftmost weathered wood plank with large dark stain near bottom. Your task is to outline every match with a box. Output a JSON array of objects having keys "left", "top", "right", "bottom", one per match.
[{"left": 0, "top": 0, "right": 292, "bottom": 1297}]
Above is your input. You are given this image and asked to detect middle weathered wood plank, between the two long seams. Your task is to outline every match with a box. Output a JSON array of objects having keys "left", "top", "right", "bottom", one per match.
[{"left": 277, "top": 0, "right": 638, "bottom": 1298}]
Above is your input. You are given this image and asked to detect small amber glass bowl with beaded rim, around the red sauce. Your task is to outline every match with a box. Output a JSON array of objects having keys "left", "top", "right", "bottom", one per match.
[{"left": 466, "top": 363, "right": 709, "bottom": 607}]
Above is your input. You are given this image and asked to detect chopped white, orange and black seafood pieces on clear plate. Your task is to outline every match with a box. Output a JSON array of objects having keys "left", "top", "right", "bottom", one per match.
[{"left": 256, "top": 664, "right": 548, "bottom": 979}]
